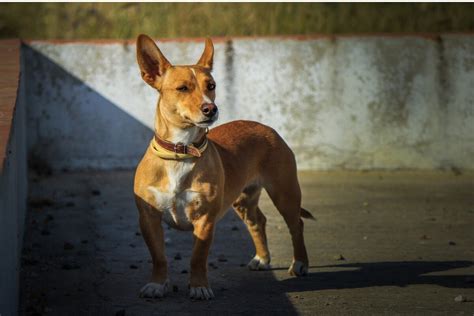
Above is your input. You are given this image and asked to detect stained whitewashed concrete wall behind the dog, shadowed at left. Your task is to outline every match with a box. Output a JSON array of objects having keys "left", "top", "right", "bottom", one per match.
[{"left": 25, "top": 35, "right": 474, "bottom": 169}]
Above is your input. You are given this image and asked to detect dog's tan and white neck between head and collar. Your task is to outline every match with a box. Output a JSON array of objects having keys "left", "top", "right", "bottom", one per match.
[{"left": 155, "top": 101, "right": 206, "bottom": 145}]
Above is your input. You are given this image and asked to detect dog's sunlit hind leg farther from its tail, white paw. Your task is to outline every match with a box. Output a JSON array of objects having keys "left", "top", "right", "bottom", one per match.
[{"left": 232, "top": 184, "right": 270, "bottom": 270}]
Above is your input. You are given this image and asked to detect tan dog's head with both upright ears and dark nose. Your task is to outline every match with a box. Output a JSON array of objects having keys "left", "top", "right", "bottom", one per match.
[{"left": 137, "top": 34, "right": 218, "bottom": 127}]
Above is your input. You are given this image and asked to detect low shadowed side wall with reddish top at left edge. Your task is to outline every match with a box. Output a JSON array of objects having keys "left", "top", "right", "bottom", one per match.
[{"left": 0, "top": 40, "right": 28, "bottom": 316}]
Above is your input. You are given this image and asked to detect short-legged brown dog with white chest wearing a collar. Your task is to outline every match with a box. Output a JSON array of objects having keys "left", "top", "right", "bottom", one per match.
[{"left": 134, "top": 35, "right": 312, "bottom": 299}]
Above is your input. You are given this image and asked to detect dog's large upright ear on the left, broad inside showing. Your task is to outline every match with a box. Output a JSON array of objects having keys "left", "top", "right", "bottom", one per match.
[{"left": 137, "top": 34, "right": 171, "bottom": 89}]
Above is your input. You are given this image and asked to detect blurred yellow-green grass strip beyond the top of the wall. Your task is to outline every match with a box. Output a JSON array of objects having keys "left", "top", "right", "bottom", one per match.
[{"left": 0, "top": 3, "right": 474, "bottom": 39}]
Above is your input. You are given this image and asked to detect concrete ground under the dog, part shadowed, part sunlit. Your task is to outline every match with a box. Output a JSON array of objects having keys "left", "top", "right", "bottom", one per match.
[{"left": 20, "top": 170, "right": 474, "bottom": 315}]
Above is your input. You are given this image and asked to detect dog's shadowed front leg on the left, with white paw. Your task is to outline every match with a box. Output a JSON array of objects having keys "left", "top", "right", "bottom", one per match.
[{"left": 140, "top": 209, "right": 169, "bottom": 297}]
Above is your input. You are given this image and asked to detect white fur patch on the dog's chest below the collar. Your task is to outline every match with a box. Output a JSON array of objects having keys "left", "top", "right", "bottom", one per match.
[{"left": 148, "top": 161, "right": 201, "bottom": 230}]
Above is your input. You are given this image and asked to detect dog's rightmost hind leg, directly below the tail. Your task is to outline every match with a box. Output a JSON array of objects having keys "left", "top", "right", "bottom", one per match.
[{"left": 264, "top": 169, "right": 308, "bottom": 276}]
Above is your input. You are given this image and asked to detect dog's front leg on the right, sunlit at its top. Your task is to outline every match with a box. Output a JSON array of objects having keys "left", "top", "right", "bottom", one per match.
[{"left": 189, "top": 215, "right": 214, "bottom": 300}]
